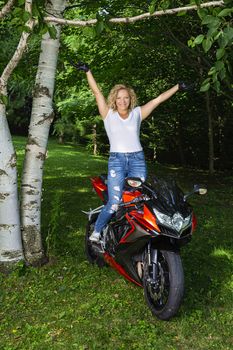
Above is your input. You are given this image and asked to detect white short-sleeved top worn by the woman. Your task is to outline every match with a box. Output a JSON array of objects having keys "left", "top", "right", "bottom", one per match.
[{"left": 104, "top": 107, "right": 142, "bottom": 153}]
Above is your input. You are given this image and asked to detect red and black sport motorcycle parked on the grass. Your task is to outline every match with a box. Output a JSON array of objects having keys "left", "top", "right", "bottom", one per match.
[{"left": 84, "top": 175, "right": 207, "bottom": 320}]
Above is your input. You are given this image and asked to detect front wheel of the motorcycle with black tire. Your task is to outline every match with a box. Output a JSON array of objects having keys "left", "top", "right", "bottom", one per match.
[{"left": 143, "top": 251, "right": 184, "bottom": 320}]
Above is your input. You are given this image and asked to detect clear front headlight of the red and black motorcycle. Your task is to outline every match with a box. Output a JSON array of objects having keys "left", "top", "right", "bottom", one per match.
[{"left": 153, "top": 208, "right": 192, "bottom": 232}]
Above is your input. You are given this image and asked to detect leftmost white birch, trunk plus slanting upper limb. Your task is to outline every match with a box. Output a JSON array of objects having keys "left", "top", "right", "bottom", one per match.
[{"left": 0, "top": 0, "right": 34, "bottom": 265}]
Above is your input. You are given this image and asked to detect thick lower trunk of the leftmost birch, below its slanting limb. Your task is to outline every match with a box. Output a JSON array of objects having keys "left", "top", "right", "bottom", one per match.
[{"left": 0, "top": 103, "right": 23, "bottom": 265}]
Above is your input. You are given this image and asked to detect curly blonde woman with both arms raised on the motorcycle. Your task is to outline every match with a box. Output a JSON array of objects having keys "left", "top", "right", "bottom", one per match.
[{"left": 75, "top": 63, "right": 188, "bottom": 242}]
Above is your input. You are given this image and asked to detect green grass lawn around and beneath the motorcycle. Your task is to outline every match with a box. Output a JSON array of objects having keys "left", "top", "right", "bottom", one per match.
[{"left": 0, "top": 137, "right": 233, "bottom": 350}]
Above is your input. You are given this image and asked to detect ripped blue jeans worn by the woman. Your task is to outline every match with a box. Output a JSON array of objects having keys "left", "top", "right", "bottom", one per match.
[{"left": 95, "top": 151, "right": 147, "bottom": 232}]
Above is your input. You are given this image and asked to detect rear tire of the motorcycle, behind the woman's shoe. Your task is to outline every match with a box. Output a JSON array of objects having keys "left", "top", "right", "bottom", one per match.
[{"left": 85, "top": 217, "right": 107, "bottom": 268}]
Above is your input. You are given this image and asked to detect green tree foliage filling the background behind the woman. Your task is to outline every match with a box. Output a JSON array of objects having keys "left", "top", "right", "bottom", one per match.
[{"left": 0, "top": 0, "right": 233, "bottom": 168}]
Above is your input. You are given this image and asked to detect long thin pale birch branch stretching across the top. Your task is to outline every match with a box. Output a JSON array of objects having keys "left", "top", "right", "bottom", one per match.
[{"left": 44, "top": 0, "right": 224, "bottom": 27}]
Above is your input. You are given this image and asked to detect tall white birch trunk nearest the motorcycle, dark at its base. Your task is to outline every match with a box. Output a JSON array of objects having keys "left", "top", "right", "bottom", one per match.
[{"left": 21, "top": 0, "right": 65, "bottom": 265}]
